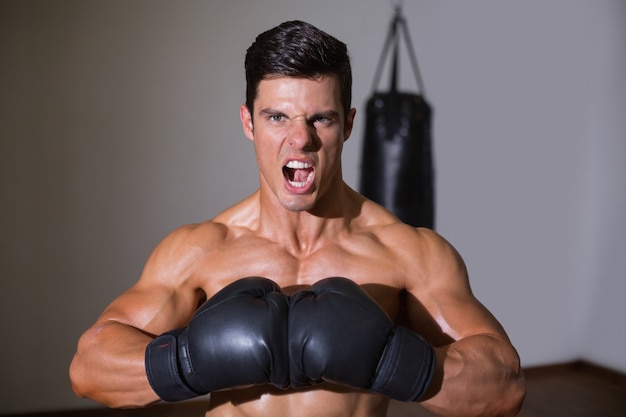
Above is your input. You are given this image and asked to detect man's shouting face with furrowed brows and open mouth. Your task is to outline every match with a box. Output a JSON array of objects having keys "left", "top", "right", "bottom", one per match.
[{"left": 240, "top": 76, "right": 355, "bottom": 211}]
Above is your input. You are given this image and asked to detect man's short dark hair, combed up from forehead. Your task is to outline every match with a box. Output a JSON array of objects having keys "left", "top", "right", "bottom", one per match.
[{"left": 245, "top": 20, "right": 352, "bottom": 117}]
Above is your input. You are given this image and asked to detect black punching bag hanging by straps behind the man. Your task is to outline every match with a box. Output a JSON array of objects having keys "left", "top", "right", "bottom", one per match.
[{"left": 360, "top": 8, "right": 435, "bottom": 229}]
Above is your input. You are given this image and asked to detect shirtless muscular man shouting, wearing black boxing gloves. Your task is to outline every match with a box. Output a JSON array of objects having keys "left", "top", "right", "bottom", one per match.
[{"left": 70, "top": 21, "right": 525, "bottom": 417}]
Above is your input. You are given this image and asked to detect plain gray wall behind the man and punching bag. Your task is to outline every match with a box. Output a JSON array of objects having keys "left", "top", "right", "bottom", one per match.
[{"left": 0, "top": 0, "right": 626, "bottom": 414}]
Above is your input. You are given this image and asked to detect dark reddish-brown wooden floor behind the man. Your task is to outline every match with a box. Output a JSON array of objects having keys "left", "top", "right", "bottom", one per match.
[{"left": 3, "top": 362, "right": 626, "bottom": 417}]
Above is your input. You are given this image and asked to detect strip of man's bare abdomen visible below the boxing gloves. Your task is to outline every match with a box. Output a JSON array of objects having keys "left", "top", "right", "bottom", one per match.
[{"left": 205, "top": 384, "right": 389, "bottom": 417}]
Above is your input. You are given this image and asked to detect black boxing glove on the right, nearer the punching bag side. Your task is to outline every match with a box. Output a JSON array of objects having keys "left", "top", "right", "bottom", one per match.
[{"left": 289, "top": 278, "right": 436, "bottom": 401}]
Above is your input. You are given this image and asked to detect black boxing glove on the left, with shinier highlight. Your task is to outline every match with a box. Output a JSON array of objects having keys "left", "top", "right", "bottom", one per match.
[{"left": 145, "top": 277, "right": 289, "bottom": 401}]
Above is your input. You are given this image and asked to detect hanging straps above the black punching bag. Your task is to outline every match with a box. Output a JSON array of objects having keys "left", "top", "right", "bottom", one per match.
[{"left": 372, "top": 6, "right": 426, "bottom": 98}]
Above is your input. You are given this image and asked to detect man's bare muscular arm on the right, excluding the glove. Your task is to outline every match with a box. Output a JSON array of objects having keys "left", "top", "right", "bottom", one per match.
[{"left": 407, "top": 231, "right": 526, "bottom": 417}]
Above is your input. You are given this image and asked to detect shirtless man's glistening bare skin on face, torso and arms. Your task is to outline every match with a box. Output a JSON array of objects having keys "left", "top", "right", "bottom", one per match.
[{"left": 70, "top": 76, "right": 525, "bottom": 417}]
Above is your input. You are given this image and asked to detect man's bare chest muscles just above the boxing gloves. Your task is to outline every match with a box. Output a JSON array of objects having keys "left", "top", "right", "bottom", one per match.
[{"left": 196, "top": 236, "right": 403, "bottom": 317}]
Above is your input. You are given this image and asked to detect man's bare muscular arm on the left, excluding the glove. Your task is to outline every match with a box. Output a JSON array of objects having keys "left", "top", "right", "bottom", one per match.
[{"left": 70, "top": 229, "right": 203, "bottom": 407}]
